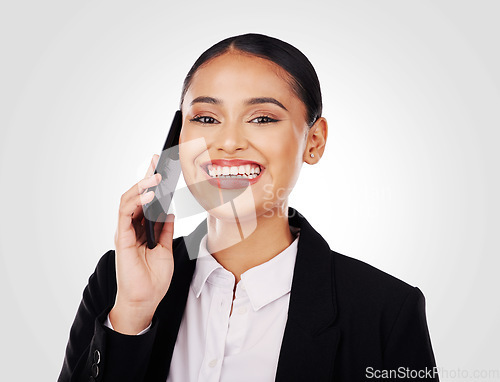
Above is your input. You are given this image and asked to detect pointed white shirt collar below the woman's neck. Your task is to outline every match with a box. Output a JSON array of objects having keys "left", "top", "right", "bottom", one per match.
[{"left": 191, "top": 227, "right": 300, "bottom": 311}]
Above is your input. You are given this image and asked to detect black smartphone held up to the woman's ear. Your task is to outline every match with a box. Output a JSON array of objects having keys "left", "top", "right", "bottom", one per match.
[{"left": 143, "top": 110, "right": 182, "bottom": 249}]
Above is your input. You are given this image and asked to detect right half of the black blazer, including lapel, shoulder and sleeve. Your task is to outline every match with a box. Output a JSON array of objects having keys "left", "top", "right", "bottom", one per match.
[{"left": 282, "top": 208, "right": 435, "bottom": 381}]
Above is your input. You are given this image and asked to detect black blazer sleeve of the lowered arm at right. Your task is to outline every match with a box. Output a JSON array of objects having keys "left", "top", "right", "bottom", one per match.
[{"left": 383, "top": 287, "right": 439, "bottom": 381}]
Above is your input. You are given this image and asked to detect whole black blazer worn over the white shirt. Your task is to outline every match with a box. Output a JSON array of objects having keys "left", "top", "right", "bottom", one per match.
[{"left": 58, "top": 208, "right": 438, "bottom": 382}]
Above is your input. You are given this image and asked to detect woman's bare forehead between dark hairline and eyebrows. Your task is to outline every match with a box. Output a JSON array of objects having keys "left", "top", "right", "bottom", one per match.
[{"left": 186, "top": 52, "right": 301, "bottom": 106}]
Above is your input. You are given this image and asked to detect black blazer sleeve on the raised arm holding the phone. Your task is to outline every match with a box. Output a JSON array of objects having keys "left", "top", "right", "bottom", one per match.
[{"left": 58, "top": 250, "right": 158, "bottom": 382}]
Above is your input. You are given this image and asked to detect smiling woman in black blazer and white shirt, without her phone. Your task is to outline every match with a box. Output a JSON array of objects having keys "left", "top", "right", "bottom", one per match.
[{"left": 59, "top": 34, "right": 437, "bottom": 382}]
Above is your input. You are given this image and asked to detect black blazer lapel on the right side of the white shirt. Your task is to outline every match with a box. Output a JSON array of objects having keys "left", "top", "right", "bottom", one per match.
[{"left": 276, "top": 208, "right": 339, "bottom": 382}]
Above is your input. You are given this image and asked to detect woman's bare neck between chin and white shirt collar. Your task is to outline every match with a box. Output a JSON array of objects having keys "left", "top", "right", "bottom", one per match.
[{"left": 207, "top": 203, "right": 293, "bottom": 282}]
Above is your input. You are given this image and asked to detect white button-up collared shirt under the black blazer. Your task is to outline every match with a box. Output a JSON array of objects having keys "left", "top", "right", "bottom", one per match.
[{"left": 106, "top": 227, "right": 299, "bottom": 382}]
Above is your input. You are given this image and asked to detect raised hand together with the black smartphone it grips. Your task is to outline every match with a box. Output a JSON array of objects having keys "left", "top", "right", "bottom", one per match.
[{"left": 109, "top": 111, "right": 182, "bottom": 335}]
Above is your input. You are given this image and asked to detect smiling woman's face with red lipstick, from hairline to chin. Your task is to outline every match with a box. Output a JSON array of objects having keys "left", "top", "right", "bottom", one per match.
[{"left": 180, "top": 52, "right": 309, "bottom": 220}]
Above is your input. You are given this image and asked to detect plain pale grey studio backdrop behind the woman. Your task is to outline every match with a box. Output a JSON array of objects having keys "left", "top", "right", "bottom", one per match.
[{"left": 0, "top": 0, "right": 500, "bottom": 381}]
